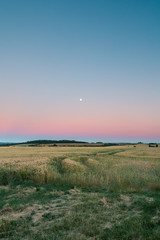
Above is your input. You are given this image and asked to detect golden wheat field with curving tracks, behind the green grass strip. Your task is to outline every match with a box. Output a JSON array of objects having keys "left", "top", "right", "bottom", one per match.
[{"left": 0, "top": 144, "right": 160, "bottom": 191}]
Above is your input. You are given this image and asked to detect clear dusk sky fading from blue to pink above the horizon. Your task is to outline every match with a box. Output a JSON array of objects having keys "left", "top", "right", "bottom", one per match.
[{"left": 0, "top": 0, "right": 160, "bottom": 142}]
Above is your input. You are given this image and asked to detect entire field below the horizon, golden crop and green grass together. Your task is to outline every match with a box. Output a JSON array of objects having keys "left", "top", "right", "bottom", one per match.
[{"left": 0, "top": 144, "right": 160, "bottom": 240}]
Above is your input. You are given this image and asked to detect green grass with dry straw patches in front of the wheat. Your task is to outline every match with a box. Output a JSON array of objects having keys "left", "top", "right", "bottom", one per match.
[{"left": 0, "top": 184, "right": 160, "bottom": 240}]
